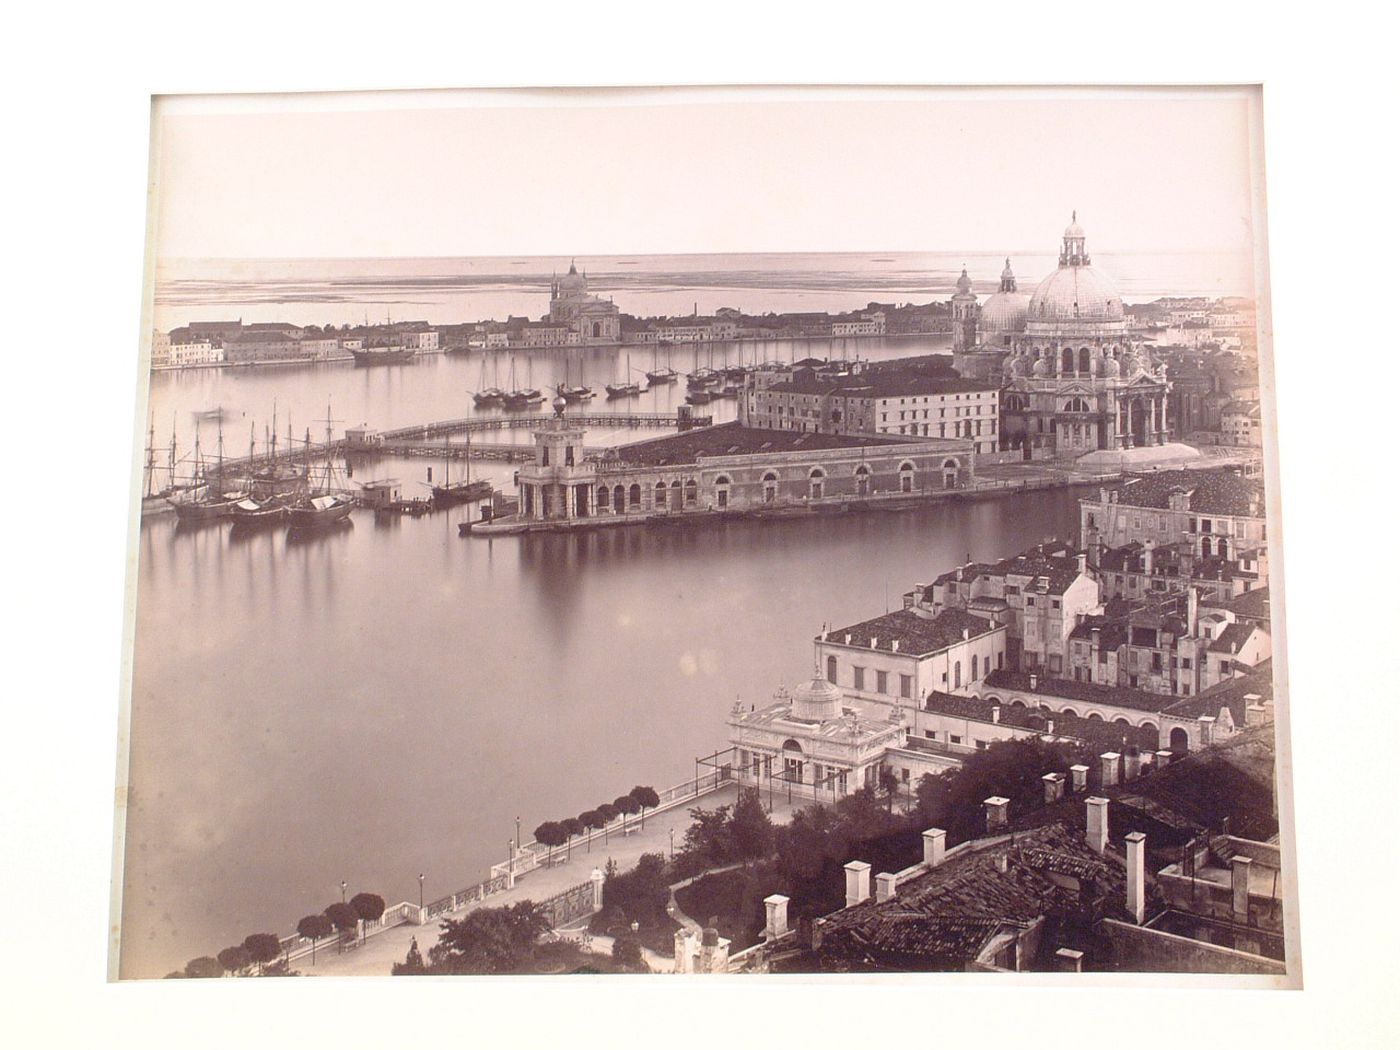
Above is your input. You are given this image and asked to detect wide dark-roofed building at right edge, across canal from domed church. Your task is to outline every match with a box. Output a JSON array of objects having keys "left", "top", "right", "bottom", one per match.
[{"left": 1079, "top": 469, "right": 1268, "bottom": 564}]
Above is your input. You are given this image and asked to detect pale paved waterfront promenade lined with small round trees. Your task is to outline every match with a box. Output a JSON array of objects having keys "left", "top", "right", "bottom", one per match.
[{"left": 291, "top": 784, "right": 811, "bottom": 977}]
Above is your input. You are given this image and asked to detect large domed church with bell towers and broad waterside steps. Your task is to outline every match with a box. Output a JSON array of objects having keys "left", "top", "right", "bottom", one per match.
[{"left": 953, "top": 214, "right": 1198, "bottom": 466}]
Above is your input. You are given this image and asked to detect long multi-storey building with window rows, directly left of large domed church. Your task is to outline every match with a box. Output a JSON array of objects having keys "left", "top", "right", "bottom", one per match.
[{"left": 739, "top": 365, "right": 1000, "bottom": 454}]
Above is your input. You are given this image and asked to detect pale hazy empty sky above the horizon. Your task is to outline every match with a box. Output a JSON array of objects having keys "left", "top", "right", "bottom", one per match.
[{"left": 155, "top": 90, "right": 1252, "bottom": 258}]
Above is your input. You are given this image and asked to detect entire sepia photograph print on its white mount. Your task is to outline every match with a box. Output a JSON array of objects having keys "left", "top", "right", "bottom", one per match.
[{"left": 109, "top": 87, "right": 1301, "bottom": 990}]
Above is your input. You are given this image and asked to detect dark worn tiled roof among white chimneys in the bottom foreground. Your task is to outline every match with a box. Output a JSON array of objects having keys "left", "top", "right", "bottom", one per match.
[{"left": 819, "top": 822, "right": 1126, "bottom": 966}]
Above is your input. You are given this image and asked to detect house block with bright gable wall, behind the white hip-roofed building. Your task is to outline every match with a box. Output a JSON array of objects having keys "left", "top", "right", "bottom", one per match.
[{"left": 904, "top": 542, "right": 1102, "bottom": 673}]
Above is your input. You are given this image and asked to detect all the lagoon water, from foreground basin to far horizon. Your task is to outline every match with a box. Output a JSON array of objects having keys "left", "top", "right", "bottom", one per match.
[{"left": 120, "top": 256, "right": 1240, "bottom": 977}]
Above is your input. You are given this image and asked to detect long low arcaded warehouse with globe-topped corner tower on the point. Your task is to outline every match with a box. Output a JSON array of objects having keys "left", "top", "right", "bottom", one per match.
[{"left": 519, "top": 399, "right": 973, "bottom": 521}]
